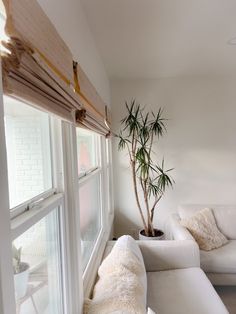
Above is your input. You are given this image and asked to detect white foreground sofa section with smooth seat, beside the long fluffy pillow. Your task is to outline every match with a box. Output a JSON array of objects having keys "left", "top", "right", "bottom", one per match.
[{"left": 101, "top": 240, "right": 228, "bottom": 314}]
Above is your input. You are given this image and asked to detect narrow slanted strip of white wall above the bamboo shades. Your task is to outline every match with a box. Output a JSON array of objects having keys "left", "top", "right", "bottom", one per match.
[{"left": 38, "top": 0, "right": 110, "bottom": 105}]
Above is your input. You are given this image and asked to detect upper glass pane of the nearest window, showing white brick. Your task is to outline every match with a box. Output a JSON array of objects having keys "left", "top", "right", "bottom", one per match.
[{"left": 4, "top": 97, "right": 52, "bottom": 208}]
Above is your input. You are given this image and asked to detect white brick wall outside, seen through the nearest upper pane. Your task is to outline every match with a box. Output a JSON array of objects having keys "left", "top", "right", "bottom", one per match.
[{"left": 6, "top": 116, "right": 50, "bottom": 207}]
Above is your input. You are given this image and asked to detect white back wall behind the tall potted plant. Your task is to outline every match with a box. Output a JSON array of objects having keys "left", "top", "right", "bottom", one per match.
[{"left": 112, "top": 78, "right": 236, "bottom": 235}]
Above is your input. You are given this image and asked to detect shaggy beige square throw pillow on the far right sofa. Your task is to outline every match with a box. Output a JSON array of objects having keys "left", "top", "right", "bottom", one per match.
[{"left": 180, "top": 208, "right": 228, "bottom": 251}]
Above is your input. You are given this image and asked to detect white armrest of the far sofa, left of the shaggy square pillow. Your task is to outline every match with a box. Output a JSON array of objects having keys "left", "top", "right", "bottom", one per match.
[{"left": 170, "top": 213, "right": 195, "bottom": 241}]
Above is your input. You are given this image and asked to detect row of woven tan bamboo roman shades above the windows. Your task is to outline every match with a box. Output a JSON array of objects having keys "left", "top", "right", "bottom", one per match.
[{"left": 2, "top": 0, "right": 110, "bottom": 135}]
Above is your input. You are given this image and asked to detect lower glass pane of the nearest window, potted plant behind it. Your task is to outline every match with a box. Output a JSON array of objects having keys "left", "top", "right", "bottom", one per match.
[{"left": 13, "top": 209, "right": 63, "bottom": 314}]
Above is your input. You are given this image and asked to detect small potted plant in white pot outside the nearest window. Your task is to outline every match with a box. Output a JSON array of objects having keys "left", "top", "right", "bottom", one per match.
[{"left": 12, "top": 244, "right": 30, "bottom": 300}]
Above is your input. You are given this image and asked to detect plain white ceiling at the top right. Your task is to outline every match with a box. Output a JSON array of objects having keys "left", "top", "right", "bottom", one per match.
[{"left": 82, "top": 0, "right": 236, "bottom": 78}]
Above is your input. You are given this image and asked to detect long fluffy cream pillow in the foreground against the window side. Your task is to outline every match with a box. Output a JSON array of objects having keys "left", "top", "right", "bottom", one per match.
[{"left": 86, "top": 236, "right": 147, "bottom": 314}]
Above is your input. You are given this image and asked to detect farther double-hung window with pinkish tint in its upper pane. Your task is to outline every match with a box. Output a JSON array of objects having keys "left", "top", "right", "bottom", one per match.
[{"left": 77, "top": 128, "right": 102, "bottom": 270}]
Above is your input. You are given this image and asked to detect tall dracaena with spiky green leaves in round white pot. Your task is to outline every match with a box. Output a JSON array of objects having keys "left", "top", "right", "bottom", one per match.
[{"left": 116, "top": 100, "right": 174, "bottom": 239}]
